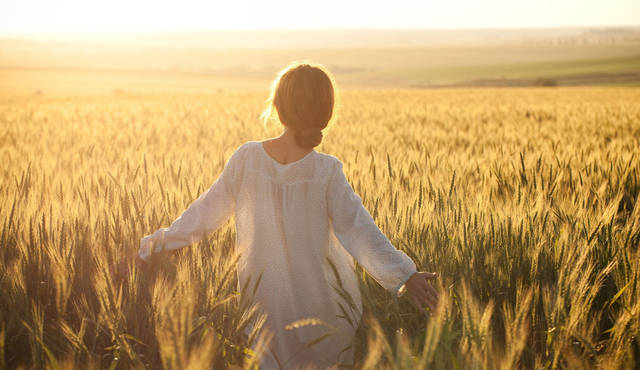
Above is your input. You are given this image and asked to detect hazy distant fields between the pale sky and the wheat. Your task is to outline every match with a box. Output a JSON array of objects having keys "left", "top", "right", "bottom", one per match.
[{"left": 0, "top": 31, "right": 640, "bottom": 94}]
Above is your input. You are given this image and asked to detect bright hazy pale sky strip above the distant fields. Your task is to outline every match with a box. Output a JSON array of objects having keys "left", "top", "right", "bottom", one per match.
[{"left": 0, "top": 0, "right": 640, "bottom": 33}]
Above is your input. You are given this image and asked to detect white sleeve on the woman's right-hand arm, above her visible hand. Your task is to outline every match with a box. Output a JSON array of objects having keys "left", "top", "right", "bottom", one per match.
[{"left": 327, "top": 161, "right": 417, "bottom": 297}]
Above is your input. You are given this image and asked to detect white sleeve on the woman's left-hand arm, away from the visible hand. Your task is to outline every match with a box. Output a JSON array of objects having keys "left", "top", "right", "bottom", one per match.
[{"left": 138, "top": 149, "right": 240, "bottom": 260}]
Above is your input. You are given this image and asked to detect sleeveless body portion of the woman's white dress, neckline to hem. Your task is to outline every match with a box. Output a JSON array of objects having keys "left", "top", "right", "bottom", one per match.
[{"left": 234, "top": 141, "right": 362, "bottom": 368}]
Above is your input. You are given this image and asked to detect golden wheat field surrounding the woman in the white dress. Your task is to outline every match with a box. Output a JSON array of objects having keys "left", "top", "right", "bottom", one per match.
[{"left": 0, "top": 88, "right": 640, "bottom": 369}]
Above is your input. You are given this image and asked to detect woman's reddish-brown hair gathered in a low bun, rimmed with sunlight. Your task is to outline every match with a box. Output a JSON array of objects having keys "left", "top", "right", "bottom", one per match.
[{"left": 260, "top": 60, "right": 337, "bottom": 148}]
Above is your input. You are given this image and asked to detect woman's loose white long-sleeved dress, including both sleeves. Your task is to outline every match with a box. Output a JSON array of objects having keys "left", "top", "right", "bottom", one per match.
[{"left": 138, "top": 141, "right": 416, "bottom": 370}]
